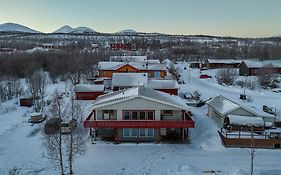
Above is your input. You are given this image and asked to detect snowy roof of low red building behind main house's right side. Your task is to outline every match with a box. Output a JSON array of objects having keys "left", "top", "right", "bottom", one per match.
[{"left": 147, "top": 79, "right": 179, "bottom": 89}]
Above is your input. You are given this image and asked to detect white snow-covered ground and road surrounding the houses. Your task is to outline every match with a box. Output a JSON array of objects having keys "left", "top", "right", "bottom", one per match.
[{"left": 0, "top": 65, "right": 281, "bottom": 175}]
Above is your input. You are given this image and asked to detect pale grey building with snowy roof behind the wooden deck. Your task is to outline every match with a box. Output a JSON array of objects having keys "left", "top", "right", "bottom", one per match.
[{"left": 206, "top": 95, "right": 275, "bottom": 126}]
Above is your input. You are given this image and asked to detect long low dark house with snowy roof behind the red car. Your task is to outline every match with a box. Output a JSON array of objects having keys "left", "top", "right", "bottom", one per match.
[{"left": 206, "top": 59, "right": 241, "bottom": 69}]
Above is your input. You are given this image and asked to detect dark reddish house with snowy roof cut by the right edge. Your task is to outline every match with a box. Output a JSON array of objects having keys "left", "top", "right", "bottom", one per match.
[{"left": 239, "top": 60, "right": 281, "bottom": 76}]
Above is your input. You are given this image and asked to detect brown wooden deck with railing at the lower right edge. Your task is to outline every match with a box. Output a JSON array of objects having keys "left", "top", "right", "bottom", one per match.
[{"left": 218, "top": 129, "right": 281, "bottom": 149}]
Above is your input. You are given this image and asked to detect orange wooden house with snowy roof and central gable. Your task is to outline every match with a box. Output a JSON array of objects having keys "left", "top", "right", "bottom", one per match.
[{"left": 98, "top": 62, "right": 167, "bottom": 78}]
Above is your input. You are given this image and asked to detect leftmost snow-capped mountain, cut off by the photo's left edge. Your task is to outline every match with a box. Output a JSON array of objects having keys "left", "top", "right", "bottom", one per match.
[{"left": 0, "top": 23, "right": 41, "bottom": 33}]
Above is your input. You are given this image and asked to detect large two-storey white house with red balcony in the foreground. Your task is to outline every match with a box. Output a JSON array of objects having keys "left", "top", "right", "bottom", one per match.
[{"left": 84, "top": 86, "right": 194, "bottom": 143}]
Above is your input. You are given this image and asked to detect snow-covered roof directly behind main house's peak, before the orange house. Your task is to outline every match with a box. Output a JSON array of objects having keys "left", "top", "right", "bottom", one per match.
[{"left": 112, "top": 73, "right": 148, "bottom": 87}]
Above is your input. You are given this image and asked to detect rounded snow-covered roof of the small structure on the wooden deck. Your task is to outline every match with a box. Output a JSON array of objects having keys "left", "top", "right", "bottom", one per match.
[{"left": 227, "top": 115, "right": 264, "bottom": 127}]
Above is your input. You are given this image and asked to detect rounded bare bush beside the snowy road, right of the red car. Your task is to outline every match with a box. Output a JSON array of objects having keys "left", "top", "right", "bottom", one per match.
[{"left": 216, "top": 68, "right": 238, "bottom": 85}]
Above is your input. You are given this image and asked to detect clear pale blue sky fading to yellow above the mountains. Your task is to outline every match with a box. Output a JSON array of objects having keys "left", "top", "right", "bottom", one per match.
[{"left": 0, "top": 0, "right": 281, "bottom": 37}]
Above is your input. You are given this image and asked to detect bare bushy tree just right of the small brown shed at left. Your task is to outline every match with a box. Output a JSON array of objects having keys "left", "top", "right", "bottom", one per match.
[{"left": 28, "top": 70, "right": 47, "bottom": 112}]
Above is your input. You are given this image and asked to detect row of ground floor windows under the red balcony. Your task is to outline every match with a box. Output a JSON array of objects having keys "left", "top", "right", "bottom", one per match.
[{"left": 123, "top": 128, "right": 154, "bottom": 137}]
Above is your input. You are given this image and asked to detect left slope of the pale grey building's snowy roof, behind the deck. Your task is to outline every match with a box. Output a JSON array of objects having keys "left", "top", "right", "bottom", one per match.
[{"left": 206, "top": 95, "right": 237, "bottom": 115}]
